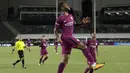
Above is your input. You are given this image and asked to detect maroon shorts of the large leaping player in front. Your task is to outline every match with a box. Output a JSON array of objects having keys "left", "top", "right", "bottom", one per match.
[{"left": 61, "top": 36, "right": 80, "bottom": 54}]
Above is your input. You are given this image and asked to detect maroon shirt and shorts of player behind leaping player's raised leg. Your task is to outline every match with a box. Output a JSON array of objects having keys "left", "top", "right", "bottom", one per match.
[{"left": 86, "top": 39, "right": 98, "bottom": 62}]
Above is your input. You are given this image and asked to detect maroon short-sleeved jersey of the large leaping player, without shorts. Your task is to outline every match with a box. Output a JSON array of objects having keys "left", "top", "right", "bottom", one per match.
[{"left": 55, "top": 14, "right": 74, "bottom": 37}]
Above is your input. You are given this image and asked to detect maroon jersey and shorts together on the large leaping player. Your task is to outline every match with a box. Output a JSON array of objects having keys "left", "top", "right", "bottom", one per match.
[{"left": 55, "top": 14, "right": 80, "bottom": 54}]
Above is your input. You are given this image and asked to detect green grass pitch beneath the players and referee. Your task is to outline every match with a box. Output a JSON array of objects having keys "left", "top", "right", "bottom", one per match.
[{"left": 0, "top": 46, "right": 130, "bottom": 73}]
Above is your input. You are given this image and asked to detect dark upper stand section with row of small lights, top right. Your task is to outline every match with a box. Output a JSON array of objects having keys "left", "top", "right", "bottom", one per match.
[{"left": 100, "top": 6, "right": 130, "bottom": 24}]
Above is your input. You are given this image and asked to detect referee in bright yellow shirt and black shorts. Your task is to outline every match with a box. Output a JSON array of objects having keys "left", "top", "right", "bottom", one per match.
[{"left": 12, "top": 39, "right": 30, "bottom": 69}]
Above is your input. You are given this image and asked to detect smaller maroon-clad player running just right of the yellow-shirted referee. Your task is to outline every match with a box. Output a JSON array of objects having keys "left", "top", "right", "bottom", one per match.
[{"left": 39, "top": 36, "right": 48, "bottom": 65}]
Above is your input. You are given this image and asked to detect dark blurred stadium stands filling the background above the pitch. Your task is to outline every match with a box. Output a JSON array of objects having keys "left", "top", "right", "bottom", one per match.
[{"left": 0, "top": 0, "right": 130, "bottom": 45}]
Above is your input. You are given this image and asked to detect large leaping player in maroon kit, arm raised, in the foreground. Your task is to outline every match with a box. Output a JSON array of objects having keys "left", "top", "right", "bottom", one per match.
[{"left": 54, "top": 3, "right": 96, "bottom": 73}]
